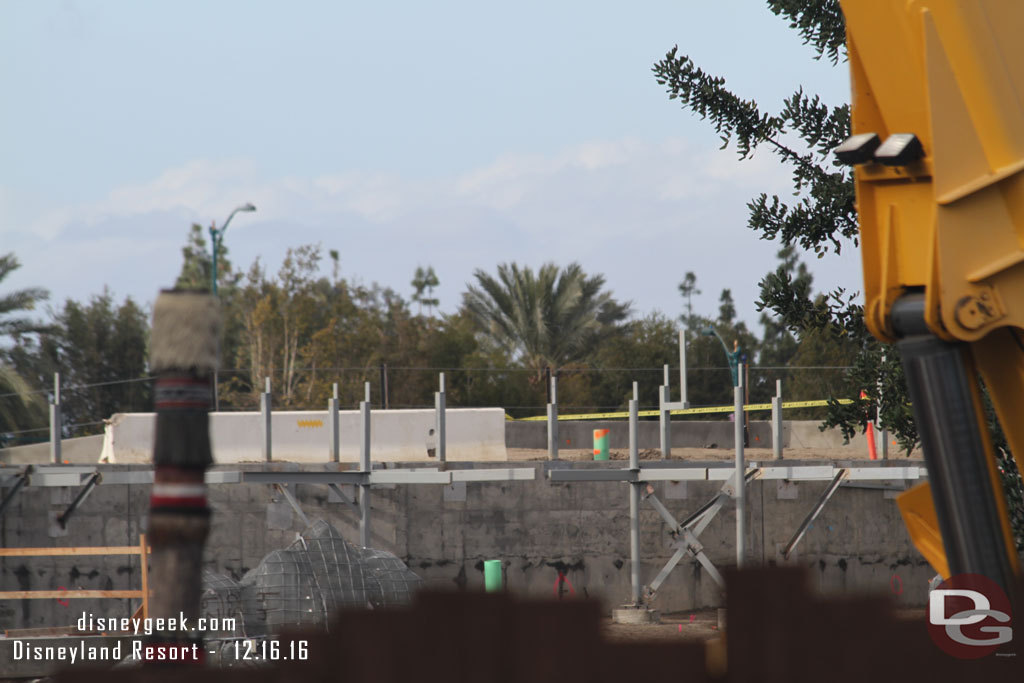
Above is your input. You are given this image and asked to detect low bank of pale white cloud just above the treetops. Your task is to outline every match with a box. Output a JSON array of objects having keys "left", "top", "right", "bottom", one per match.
[{"left": 0, "top": 138, "right": 859, "bottom": 322}]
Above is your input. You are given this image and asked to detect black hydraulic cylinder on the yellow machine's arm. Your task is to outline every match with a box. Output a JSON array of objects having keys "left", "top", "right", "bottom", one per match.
[{"left": 892, "top": 295, "right": 1013, "bottom": 594}]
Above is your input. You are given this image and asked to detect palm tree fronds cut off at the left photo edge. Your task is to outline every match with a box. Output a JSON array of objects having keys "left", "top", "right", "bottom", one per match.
[{"left": 0, "top": 254, "right": 49, "bottom": 438}]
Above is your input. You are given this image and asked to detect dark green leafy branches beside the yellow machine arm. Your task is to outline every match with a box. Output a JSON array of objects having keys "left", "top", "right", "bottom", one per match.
[{"left": 652, "top": 0, "right": 916, "bottom": 444}]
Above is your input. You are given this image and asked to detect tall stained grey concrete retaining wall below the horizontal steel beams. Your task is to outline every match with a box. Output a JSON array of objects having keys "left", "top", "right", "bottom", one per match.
[{"left": 0, "top": 463, "right": 933, "bottom": 629}]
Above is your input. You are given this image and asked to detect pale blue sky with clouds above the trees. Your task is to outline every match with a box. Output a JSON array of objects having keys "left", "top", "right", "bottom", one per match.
[{"left": 0, "top": 0, "right": 861, "bottom": 326}]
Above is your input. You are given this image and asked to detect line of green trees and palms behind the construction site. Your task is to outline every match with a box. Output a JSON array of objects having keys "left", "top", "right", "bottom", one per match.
[{"left": 0, "top": 225, "right": 856, "bottom": 442}]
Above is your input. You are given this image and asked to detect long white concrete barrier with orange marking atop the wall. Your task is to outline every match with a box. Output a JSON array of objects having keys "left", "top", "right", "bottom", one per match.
[{"left": 100, "top": 409, "right": 507, "bottom": 464}]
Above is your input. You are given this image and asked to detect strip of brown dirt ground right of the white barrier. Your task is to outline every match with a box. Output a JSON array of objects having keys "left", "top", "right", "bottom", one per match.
[{"left": 506, "top": 447, "right": 920, "bottom": 464}]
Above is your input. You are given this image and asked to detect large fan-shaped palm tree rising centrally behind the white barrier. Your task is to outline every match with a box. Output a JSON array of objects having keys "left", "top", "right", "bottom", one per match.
[{"left": 463, "top": 263, "right": 629, "bottom": 381}]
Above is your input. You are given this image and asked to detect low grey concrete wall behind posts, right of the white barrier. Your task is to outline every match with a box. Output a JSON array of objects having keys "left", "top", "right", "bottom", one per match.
[{"left": 505, "top": 420, "right": 867, "bottom": 453}]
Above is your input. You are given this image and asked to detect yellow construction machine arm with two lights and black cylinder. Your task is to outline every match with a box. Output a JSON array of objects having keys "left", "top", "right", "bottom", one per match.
[{"left": 836, "top": 0, "right": 1024, "bottom": 591}]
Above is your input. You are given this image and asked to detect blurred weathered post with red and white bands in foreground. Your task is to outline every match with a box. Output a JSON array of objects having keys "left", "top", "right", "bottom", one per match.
[{"left": 144, "top": 290, "right": 220, "bottom": 661}]
